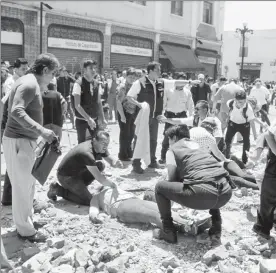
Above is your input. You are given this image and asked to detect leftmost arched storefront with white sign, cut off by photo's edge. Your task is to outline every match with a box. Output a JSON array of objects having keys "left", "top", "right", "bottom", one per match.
[{"left": 1, "top": 17, "right": 24, "bottom": 65}]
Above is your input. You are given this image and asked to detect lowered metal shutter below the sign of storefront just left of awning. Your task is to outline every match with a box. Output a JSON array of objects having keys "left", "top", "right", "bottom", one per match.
[{"left": 110, "top": 53, "right": 152, "bottom": 69}]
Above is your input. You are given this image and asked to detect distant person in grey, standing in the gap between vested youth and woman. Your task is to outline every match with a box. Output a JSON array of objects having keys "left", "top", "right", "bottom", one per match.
[{"left": 107, "top": 70, "right": 120, "bottom": 121}]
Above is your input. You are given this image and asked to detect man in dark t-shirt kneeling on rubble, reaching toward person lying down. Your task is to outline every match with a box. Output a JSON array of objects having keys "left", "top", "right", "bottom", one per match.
[{"left": 47, "top": 131, "right": 123, "bottom": 206}]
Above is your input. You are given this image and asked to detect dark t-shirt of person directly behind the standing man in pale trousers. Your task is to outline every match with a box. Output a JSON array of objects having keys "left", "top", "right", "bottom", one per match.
[{"left": 42, "top": 91, "right": 63, "bottom": 127}]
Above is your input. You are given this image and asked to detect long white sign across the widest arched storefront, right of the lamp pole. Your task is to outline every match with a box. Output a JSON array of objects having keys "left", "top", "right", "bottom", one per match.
[{"left": 48, "top": 37, "right": 102, "bottom": 52}]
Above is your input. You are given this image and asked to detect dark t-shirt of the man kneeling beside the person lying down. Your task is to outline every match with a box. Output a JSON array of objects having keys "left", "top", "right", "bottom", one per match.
[{"left": 58, "top": 140, "right": 109, "bottom": 181}]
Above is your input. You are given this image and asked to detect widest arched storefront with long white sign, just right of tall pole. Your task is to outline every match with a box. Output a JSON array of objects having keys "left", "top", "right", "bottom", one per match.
[{"left": 48, "top": 25, "right": 103, "bottom": 73}]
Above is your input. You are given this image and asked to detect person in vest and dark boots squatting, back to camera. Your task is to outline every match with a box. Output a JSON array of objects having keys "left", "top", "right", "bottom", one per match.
[{"left": 155, "top": 125, "right": 234, "bottom": 243}]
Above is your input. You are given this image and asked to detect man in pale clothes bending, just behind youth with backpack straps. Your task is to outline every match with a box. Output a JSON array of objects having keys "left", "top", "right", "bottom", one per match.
[{"left": 213, "top": 79, "right": 244, "bottom": 132}]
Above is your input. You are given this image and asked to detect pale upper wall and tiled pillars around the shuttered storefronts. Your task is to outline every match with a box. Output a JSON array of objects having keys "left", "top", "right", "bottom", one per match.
[{"left": 1, "top": 0, "right": 224, "bottom": 73}]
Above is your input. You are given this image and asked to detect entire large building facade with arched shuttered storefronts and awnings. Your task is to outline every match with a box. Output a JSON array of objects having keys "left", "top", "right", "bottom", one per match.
[{"left": 1, "top": 1, "right": 224, "bottom": 77}]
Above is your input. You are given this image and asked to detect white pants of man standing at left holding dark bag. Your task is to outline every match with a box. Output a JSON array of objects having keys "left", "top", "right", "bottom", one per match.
[{"left": 3, "top": 136, "right": 36, "bottom": 236}]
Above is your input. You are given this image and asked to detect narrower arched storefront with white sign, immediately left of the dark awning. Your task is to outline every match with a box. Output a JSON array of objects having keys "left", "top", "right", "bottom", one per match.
[{"left": 110, "top": 34, "right": 153, "bottom": 70}]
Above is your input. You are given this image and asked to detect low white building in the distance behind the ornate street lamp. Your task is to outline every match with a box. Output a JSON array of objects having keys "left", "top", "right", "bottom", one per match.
[{"left": 222, "top": 29, "right": 276, "bottom": 81}]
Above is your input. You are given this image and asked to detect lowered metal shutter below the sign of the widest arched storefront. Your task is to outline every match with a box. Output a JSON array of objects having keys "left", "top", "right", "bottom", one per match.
[{"left": 48, "top": 47, "right": 102, "bottom": 73}]
